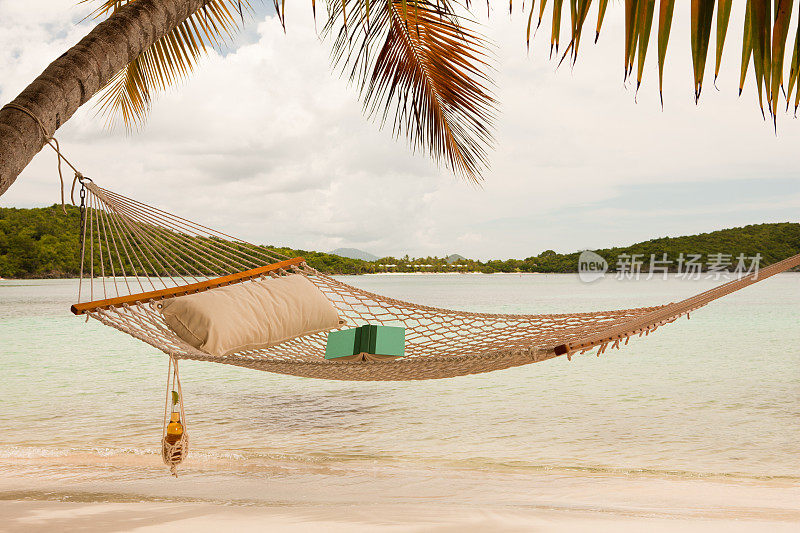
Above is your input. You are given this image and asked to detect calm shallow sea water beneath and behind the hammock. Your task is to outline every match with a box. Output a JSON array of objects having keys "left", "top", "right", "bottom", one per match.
[{"left": 0, "top": 273, "right": 800, "bottom": 498}]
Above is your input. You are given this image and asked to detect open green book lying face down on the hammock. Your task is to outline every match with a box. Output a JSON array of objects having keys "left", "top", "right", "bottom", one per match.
[{"left": 325, "top": 324, "right": 405, "bottom": 361}]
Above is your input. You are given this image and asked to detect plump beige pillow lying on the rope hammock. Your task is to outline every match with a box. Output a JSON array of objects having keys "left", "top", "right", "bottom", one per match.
[{"left": 161, "top": 274, "right": 344, "bottom": 357}]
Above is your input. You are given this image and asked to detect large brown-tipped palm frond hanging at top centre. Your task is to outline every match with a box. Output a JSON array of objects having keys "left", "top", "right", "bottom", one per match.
[{"left": 324, "top": 0, "right": 495, "bottom": 181}]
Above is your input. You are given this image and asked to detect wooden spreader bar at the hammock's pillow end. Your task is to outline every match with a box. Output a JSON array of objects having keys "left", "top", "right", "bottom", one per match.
[{"left": 70, "top": 257, "right": 305, "bottom": 315}]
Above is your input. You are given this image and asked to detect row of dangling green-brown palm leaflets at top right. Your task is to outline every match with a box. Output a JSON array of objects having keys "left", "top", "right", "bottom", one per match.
[{"left": 526, "top": 0, "right": 800, "bottom": 122}]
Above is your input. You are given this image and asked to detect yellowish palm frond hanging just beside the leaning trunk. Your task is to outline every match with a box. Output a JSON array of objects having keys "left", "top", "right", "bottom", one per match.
[{"left": 86, "top": 0, "right": 252, "bottom": 130}]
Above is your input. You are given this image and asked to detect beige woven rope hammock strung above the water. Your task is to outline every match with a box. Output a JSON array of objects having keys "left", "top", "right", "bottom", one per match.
[{"left": 72, "top": 178, "right": 800, "bottom": 380}]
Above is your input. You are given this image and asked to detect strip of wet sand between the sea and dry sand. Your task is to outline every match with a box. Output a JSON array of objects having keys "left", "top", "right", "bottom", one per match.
[{"left": 0, "top": 450, "right": 800, "bottom": 504}]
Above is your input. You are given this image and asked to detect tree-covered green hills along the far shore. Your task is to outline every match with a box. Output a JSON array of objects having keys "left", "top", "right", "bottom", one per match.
[{"left": 0, "top": 205, "right": 800, "bottom": 278}]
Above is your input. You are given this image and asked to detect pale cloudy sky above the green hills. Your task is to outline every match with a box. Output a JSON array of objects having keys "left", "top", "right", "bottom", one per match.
[{"left": 0, "top": 0, "right": 800, "bottom": 259}]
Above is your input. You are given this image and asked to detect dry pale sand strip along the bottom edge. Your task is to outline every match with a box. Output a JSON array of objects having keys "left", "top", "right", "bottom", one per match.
[{"left": 6, "top": 501, "right": 800, "bottom": 533}]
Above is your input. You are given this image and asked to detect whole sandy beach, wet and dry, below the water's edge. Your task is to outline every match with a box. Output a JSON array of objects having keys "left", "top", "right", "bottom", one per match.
[{"left": 0, "top": 457, "right": 800, "bottom": 533}]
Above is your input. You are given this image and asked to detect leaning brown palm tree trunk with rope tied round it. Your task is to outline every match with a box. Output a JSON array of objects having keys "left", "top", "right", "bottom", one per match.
[{"left": 0, "top": 0, "right": 206, "bottom": 195}]
